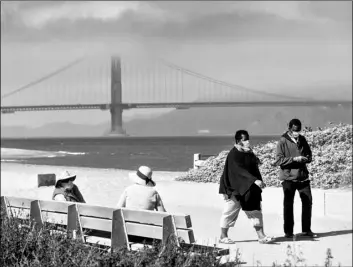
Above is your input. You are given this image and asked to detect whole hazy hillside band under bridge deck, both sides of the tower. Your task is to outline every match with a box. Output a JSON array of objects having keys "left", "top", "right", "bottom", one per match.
[{"left": 1, "top": 107, "right": 352, "bottom": 137}]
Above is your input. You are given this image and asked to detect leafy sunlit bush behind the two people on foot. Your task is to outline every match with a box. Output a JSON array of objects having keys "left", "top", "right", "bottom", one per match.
[{"left": 176, "top": 124, "right": 352, "bottom": 189}]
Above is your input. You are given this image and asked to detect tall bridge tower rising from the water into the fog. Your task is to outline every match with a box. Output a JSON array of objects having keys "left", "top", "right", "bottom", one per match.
[{"left": 110, "top": 56, "right": 126, "bottom": 136}]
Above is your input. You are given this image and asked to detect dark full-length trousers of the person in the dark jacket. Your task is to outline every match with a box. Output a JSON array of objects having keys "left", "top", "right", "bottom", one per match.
[{"left": 282, "top": 181, "right": 313, "bottom": 234}]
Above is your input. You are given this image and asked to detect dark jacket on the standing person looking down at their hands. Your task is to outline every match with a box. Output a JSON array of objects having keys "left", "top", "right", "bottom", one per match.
[{"left": 275, "top": 132, "right": 312, "bottom": 181}]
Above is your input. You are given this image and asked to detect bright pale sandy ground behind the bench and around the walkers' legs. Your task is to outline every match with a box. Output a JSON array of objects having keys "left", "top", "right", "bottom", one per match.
[{"left": 1, "top": 163, "right": 352, "bottom": 266}]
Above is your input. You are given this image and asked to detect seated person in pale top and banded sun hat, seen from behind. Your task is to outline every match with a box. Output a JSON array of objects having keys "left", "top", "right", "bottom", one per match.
[{"left": 117, "top": 166, "right": 166, "bottom": 212}]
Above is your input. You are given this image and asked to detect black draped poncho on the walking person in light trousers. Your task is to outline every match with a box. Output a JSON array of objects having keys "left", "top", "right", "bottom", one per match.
[{"left": 219, "top": 147, "right": 262, "bottom": 213}]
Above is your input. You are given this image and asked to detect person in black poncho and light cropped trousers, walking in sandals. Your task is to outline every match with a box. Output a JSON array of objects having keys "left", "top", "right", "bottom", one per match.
[{"left": 219, "top": 130, "right": 274, "bottom": 244}]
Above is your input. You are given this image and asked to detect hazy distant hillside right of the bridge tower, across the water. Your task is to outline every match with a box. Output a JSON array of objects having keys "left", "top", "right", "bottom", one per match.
[{"left": 125, "top": 107, "right": 352, "bottom": 135}]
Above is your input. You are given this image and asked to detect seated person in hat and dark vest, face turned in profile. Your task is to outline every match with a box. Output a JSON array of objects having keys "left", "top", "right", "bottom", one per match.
[{"left": 52, "top": 171, "right": 86, "bottom": 203}]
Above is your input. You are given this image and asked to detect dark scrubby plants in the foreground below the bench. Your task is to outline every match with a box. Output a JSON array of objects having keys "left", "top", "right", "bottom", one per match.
[{"left": 0, "top": 210, "right": 240, "bottom": 267}]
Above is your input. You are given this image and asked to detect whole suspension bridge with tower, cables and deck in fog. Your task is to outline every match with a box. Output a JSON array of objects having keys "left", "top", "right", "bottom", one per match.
[{"left": 1, "top": 55, "right": 352, "bottom": 135}]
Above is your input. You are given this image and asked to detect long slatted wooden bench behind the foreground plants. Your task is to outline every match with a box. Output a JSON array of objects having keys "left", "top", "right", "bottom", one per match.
[{"left": 1, "top": 196, "right": 229, "bottom": 255}]
